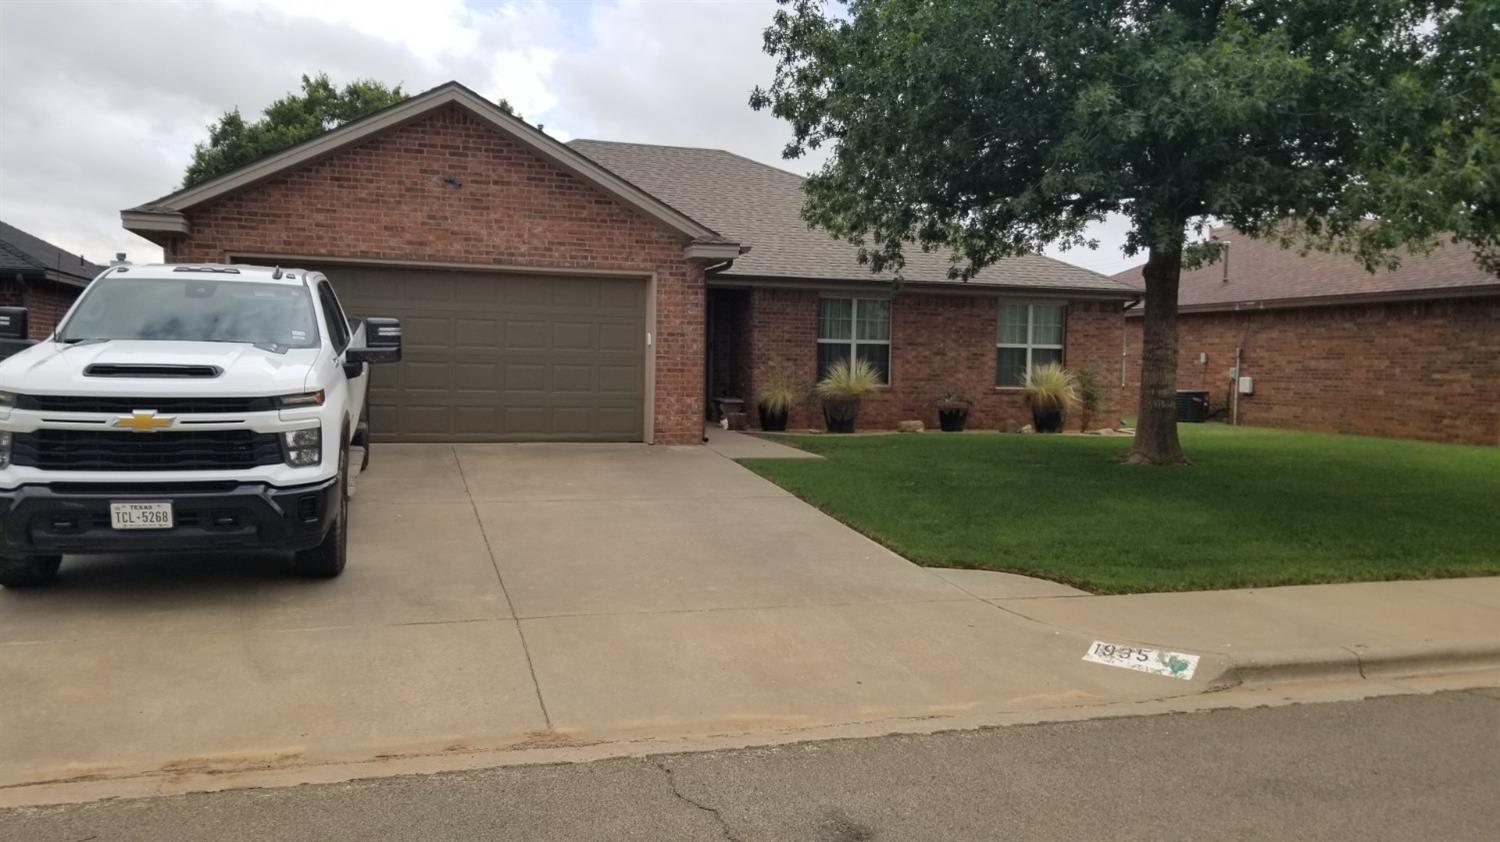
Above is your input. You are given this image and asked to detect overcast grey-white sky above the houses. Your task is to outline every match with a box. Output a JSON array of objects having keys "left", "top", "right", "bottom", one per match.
[{"left": 0, "top": 0, "right": 1145, "bottom": 273}]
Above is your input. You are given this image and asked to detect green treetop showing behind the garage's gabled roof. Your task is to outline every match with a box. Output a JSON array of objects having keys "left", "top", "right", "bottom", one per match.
[{"left": 183, "top": 74, "right": 407, "bottom": 188}]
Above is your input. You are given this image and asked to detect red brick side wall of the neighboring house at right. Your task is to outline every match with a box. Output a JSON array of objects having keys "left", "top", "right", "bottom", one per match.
[{"left": 1127, "top": 297, "right": 1500, "bottom": 444}]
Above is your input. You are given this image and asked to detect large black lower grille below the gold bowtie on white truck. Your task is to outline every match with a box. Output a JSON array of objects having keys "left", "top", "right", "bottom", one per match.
[{"left": 11, "top": 429, "right": 284, "bottom": 471}]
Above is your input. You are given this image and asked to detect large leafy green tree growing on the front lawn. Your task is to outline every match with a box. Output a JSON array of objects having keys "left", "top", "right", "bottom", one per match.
[{"left": 750, "top": 0, "right": 1500, "bottom": 464}]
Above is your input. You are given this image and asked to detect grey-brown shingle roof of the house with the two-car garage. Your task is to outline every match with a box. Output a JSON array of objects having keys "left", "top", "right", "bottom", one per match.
[{"left": 569, "top": 140, "right": 1130, "bottom": 293}]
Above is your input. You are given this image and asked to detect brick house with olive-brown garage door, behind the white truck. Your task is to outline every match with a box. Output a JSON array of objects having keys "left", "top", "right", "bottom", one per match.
[{"left": 122, "top": 83, "right": 1137, "bottom": 444}]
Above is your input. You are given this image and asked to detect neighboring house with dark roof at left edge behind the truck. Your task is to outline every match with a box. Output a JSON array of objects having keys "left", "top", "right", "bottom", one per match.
[{"left": 0, "top": 222, "right": 105, "bottom": 339}]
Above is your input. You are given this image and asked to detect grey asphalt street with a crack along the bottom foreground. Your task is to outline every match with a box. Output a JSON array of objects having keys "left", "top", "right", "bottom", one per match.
[{"left": 0, "top": 689, "right": 1500, "bottom": 842}]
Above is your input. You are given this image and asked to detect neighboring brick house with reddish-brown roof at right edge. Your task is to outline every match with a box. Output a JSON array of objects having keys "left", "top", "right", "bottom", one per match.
[{"left": 1115, "top": 228, "right": 1500, "bottom": 444}]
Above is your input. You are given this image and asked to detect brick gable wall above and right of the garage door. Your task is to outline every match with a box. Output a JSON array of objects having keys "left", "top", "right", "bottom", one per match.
[{"left": 167, "top": 107, "right": 705, "bottom": 444}]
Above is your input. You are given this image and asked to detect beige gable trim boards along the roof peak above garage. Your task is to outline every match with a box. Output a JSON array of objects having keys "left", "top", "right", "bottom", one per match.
[{"left": 120, "top": 83, "right": 738, "bottom": 254}]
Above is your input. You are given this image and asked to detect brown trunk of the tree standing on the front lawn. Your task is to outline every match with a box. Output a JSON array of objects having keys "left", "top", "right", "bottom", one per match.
[{"left": 1128, "top": 234, "right": 1187, "bottom": 465}]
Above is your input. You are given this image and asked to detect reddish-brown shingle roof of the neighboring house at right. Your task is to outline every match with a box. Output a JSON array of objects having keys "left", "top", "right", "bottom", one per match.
[{"left": 1115, "top": 228, "right": 1500, "bottom": 309}]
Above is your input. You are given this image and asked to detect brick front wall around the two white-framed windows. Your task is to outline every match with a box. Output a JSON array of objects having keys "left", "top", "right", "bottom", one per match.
[{"left": 747, "top": 290, "right": 1122, "bottom": 429}]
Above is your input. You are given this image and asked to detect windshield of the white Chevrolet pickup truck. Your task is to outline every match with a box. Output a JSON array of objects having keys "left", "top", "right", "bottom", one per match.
[{"left": 57, "top": 278, "right": 318, "bottom": 348}]
